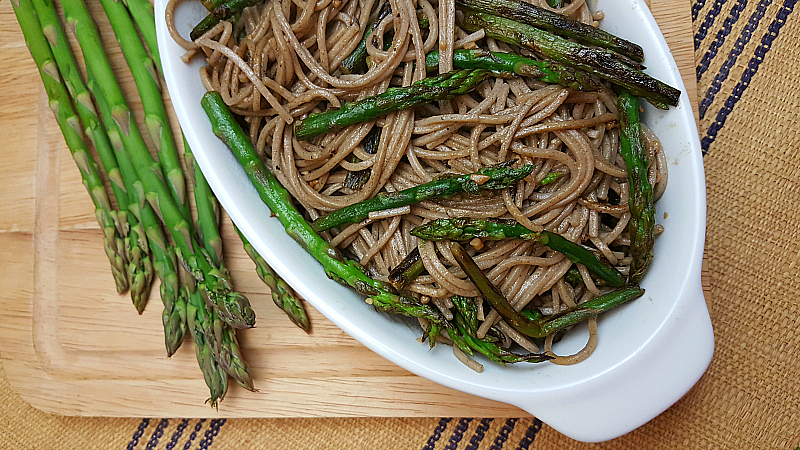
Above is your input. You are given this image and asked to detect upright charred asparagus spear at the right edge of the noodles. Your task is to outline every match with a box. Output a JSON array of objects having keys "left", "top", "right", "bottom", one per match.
[{"left": 617, "top": 89, "right": 656, "bottom": 283}]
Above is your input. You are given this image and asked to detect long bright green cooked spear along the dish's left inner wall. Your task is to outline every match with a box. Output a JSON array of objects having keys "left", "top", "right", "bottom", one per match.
[{"left": 201, "top": 92, "right": 450, "bottom": 342}]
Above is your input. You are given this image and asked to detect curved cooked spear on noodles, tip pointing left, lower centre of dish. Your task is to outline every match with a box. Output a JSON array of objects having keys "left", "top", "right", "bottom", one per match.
[{"left": 411, "top": 217, "right": 625, "bottom": 287}]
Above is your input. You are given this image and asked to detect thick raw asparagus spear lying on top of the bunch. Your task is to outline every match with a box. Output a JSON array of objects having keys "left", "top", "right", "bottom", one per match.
[{"left": 62, "top": 0, "right": 255, "bottom": 328}]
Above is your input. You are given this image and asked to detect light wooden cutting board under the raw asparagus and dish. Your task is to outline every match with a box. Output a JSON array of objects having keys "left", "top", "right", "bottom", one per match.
[{"left": 0, "top": 0, "right": 696, "bottom": 417}]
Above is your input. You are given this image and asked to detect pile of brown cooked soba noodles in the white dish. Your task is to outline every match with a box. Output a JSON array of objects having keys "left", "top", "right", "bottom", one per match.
[{"left": 168, "top": 0, "right": 667, "bottom": 369}]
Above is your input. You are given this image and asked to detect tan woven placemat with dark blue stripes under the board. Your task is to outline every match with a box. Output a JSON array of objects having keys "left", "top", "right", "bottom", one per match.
[{"left": 0, "top": 0, "right": 800, "bottom": 450}]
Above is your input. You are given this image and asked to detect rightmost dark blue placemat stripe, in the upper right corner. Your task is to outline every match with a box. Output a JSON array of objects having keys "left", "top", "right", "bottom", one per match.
[{"left": 700, "top": 0, "right": 797, "bottom": 155}]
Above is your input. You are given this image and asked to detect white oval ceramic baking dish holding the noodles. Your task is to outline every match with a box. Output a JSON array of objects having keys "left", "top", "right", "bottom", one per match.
[{"left": 155, "top": 0, "right": 714, "bottom": 442}]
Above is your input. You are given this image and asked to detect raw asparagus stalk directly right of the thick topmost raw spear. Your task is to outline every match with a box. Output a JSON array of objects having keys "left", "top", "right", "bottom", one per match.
[{"left": 100, "top": 0, "right": 189, "bottom": 217}]
